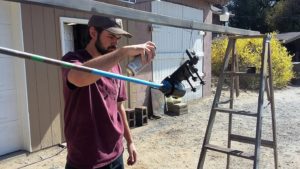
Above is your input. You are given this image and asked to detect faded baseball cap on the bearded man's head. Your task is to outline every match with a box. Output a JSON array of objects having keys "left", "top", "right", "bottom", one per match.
[{"left": 88, "top": 15, "right": 132, "bottom": 38}]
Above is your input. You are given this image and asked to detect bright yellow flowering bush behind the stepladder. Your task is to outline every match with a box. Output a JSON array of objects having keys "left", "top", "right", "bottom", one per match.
[{"left": 212, "top": 33, "right": 294, "bottom": 89}]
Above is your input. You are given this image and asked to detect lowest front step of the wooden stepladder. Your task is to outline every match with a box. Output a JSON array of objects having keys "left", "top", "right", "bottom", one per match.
[{"left": 205, "top": 144, "right": 254, "bottom": 160}]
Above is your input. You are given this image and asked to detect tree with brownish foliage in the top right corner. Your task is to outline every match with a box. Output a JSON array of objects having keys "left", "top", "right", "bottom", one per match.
[{"left": 266, "top": 0, "right": 300, "bottom": 32}]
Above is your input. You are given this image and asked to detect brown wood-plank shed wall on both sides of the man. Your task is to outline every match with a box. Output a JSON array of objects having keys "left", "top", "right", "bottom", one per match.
[{"left": 21, "top": 0, "right": 211, "bottom": 151}]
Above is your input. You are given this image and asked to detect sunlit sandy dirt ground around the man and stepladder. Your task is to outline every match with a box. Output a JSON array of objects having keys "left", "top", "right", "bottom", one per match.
[{"left": 0, "top": 86, "right": 300, "bottom": 169}]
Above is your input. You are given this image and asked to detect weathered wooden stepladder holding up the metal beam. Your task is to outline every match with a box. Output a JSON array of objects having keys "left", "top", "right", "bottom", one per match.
[{"left": 197, "top": 35, "right": 278, "bottom": 169}]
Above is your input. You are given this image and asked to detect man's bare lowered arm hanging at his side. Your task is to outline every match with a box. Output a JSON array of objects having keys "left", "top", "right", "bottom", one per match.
[{"left": 118, "top": 102, "right": 137, "bottom": 165}]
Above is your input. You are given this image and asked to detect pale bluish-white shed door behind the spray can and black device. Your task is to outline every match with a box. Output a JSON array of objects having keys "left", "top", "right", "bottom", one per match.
[{"left": 152, "top": 1, "right": 204, "bottom": 101}]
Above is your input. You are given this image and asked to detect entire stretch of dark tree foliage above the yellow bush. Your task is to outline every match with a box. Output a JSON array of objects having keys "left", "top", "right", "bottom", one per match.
[{"left": 228, "top": 0, "right": 300, "bottom": 33}]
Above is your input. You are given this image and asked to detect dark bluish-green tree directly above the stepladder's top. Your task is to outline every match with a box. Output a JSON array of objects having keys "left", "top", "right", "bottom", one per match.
[{"left": 228, "top": 0, "right": 279, "bottom": 33}]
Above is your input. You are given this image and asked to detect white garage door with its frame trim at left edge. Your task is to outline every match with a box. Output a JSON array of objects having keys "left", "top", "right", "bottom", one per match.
[{"left": 0, "top": 1, "right": 30, "bottom": 155}]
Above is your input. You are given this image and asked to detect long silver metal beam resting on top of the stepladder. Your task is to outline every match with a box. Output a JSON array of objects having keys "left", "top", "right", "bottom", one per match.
[{"left": 6, "top": 0, "right": 260, "bottom": 35}]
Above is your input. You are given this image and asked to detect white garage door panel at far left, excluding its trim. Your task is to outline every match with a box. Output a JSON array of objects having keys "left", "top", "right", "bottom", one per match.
[{"left": 0, "top": 1, "right": 24, "bottom": 155}]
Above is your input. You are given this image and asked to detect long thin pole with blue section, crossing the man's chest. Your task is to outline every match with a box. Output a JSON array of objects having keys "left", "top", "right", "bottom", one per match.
[{"left": 0, "top": 47, "right": 164, "bottom": 89}]
